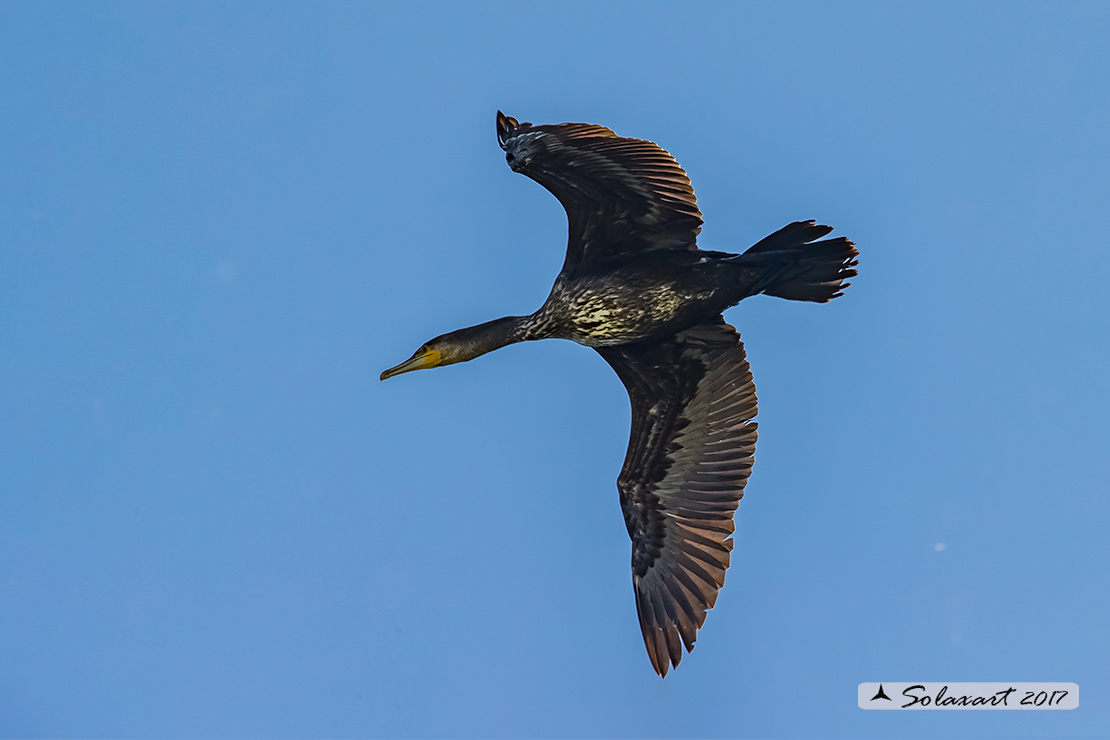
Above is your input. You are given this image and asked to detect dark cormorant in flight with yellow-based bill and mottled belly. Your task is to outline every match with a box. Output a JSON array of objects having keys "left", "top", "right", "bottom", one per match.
[{"left": 382, "top": 111, "right": 859, "bottom": 676}]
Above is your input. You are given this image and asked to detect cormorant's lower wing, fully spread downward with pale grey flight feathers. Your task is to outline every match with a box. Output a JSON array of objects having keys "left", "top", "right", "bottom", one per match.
[{"left": 597, "top": 318, "right": 756, "bottom": 676}]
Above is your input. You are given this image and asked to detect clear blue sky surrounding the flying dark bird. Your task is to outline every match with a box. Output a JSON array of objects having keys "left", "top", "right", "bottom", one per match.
[{"left": 0, "top": 2, "right": 1110, "bottom": 738}]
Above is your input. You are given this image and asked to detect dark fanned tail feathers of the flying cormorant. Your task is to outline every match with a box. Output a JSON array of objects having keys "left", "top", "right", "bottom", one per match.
[{"left": 737, "top": 221, "right": 859, "bottom": 303}]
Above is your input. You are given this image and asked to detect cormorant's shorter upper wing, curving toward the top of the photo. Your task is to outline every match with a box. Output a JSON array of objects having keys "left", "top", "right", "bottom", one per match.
[{"left": 497, "top": 111, "right": 702, "bottom": 270}]
